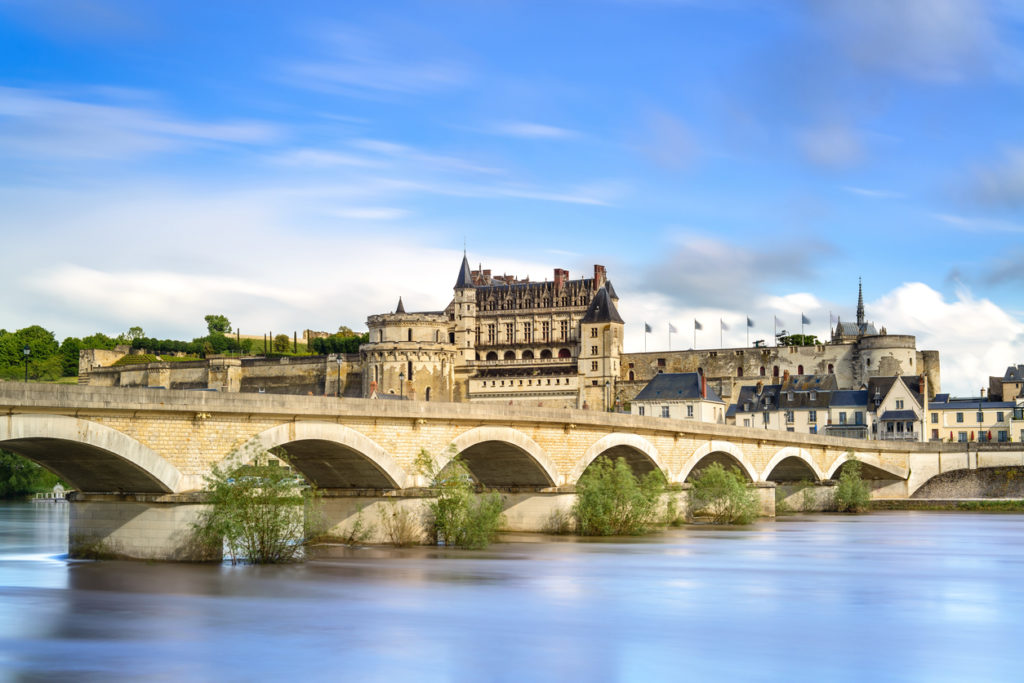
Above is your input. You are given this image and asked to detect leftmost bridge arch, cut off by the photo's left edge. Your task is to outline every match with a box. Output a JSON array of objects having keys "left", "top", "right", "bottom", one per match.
[{"left": 0, "top": 415, "right": 186, "bottom": 494}]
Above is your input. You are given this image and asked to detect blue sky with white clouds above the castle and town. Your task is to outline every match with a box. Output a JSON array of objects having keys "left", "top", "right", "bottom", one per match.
[{"left": 0, "top": 0, "right": 1024, "bottom": 393}]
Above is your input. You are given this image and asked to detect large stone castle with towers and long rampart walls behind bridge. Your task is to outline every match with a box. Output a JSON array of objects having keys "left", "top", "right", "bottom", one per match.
[{"left": 80, "top": 254, "right": 940, "bottom": 410}]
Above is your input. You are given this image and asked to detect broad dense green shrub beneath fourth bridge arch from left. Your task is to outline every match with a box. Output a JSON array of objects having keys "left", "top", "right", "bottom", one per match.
[{"left": 572, "top": 457, "right": 666, "bottom": 536}]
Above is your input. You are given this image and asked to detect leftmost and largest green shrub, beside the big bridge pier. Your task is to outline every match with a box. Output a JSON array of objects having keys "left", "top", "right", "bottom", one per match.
[{"left": 194, "top": 448, "right": 318, "bottom": 564}]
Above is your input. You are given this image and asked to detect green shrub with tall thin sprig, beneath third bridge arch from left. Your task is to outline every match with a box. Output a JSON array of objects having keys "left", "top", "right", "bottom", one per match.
[{"left": 417, "top": 450, "right": 504, "bottom": 549}]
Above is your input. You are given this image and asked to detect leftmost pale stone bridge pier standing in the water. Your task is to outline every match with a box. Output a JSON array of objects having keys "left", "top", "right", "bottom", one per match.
[{"left": 68, "top": 492, "right": 221, "bottom": 562}]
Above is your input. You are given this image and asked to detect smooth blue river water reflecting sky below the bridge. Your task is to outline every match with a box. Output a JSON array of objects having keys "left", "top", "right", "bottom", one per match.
[{"left": 0, "top": 504, "right": 1024, "bottom": 683}]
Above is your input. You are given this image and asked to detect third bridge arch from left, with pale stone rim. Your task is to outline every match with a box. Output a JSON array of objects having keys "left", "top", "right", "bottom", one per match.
[{"left": 450, "top": 427, "right": 558, "bottom": 486}]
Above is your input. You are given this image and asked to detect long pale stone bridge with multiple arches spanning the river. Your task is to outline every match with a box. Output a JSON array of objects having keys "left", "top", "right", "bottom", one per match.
[{"left": 0, "top": 382, "right": 1024, "bottom": 557}]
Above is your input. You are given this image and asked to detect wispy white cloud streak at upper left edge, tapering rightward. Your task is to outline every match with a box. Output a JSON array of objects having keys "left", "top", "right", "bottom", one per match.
[{"left": 0, "top": 87, "right": 282, "bottom": 159}]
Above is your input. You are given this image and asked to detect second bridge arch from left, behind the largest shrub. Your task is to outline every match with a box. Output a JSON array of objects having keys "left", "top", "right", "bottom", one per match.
[{"left": 230, "top": 421, "right": 410, "bottom": 488}]
